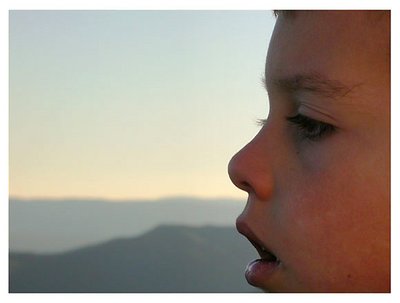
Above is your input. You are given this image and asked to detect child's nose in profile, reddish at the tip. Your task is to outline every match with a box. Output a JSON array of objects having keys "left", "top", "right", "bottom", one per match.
[{"left": 228, "top": 132, "right": 274, "bottom": 200}]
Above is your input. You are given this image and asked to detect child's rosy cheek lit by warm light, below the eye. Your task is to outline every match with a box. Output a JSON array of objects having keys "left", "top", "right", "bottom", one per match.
[{"left": 277, "top": 145, "right": 390, "bottom": 291}]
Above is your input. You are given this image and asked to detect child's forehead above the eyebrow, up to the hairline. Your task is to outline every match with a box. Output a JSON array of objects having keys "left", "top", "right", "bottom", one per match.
[{"left": 266, "top": 11, "right": 390, "bottom": 83}]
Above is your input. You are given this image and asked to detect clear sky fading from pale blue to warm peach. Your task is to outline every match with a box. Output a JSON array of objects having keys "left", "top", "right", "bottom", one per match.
[{"left": 9, "top": 11, "right": 275, "bottom": 199}]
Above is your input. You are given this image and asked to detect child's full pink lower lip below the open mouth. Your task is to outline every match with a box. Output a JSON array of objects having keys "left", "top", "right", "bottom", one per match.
[{"left": 245, "top": 259, "right": 280, "bottom": 286}]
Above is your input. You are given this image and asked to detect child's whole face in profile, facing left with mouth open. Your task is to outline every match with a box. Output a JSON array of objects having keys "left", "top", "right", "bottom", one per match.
[{"left": 229, "top": 11, "right": 390, "bottom": 292}]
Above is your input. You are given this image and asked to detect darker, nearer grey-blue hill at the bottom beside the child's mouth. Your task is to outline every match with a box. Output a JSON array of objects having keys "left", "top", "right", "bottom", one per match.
[{"left": 9, "top": 226, "right": 257, "bottom": 293}]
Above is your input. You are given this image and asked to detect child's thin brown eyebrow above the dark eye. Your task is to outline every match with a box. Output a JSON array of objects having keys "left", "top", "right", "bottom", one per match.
[{"left": 263, "top": 73, "right": 361, "bottom": 99}]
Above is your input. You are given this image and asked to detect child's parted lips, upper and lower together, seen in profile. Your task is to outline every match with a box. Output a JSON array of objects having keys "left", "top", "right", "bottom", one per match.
[{"left": 236, "top": 218, "right": 282, "bottom": 287}]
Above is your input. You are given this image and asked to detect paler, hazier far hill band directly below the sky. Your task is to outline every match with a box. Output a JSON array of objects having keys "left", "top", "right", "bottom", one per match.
[{"left": 9, "top": 197, "right": 245, "bottom": 253}]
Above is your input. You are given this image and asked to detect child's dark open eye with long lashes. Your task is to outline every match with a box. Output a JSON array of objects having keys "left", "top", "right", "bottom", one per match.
[{"left": 286, "top": 114, "right": 336, "bottom": 141}]
